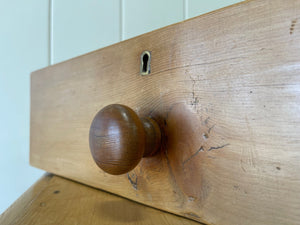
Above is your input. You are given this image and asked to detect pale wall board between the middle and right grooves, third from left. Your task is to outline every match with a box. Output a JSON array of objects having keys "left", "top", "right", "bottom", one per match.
[{"left": 122, "top": 0, "right": 184, "bottom": 39}]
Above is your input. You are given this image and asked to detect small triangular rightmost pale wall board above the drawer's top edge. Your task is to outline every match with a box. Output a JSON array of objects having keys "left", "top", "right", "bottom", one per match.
[{"left": 187, "top": 0, "right": 242, "bottom": 18}]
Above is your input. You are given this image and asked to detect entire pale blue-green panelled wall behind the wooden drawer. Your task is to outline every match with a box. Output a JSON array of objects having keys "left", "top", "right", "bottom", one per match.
[{"left": 0, "top": 0, "right": 239, "bottom": 213}]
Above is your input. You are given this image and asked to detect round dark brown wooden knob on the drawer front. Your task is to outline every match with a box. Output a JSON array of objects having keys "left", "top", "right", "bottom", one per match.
[{"left": 89, "top": 104, "right": 161, "bottom": 175}]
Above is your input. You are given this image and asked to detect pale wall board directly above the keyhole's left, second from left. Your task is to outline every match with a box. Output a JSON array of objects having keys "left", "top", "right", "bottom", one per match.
[{"left": 51, "top": 0, "right": 121, "bottom": 63}]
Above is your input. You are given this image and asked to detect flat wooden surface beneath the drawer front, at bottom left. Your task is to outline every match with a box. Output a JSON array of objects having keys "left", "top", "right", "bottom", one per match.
[{"left": 0, "top": 174, "right": 199, "bottom": 225}]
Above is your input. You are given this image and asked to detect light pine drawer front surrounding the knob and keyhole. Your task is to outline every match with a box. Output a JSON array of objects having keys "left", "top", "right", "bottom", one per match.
[{"left": 30, "top": 0, "right": 300, "bottom": 225}]
